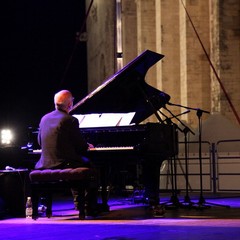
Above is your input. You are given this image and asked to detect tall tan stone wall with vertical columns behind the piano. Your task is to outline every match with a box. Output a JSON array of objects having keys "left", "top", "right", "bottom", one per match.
[{"left": 86, "top": 0, "right": 240, "bottom": 127}]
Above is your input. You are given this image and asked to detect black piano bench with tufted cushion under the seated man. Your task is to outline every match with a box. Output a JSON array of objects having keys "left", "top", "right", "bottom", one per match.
[{"left": 29, "top": 167, "right": 93, "bottom": 219}]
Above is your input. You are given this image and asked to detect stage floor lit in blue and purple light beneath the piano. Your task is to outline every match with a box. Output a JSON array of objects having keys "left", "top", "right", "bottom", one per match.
[{"left": 0, "top": 193, "right": 240, "bottom": 240}]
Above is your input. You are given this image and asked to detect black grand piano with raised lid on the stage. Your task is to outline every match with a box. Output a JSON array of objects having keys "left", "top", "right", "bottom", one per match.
[{"left": 27, "top": 50, "right": 178, "bottom": 208}]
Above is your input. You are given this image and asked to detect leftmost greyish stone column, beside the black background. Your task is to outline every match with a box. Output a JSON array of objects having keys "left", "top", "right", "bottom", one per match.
[{"left": 86, "top": 0, "right": 116, "bottom": 92}]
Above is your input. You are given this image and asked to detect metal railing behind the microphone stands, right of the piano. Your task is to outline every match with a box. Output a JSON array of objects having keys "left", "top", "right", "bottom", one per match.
[{"left": 160, "top": 139, "right": 240, "bottom": 193}]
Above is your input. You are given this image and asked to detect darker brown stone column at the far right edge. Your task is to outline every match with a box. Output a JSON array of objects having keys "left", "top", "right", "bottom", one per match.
[{"left": 210, "top": 0, "right": 240, "bottom": 123}]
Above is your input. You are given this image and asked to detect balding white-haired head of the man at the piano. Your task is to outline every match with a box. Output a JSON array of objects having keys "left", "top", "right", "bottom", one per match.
[{"left": 54, "top": 90, "right": 73, "bottom": 112}]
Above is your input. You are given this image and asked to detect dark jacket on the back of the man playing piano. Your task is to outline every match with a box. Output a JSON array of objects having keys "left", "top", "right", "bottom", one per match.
[{"left": 36, "top": 110, "right": 88, "bottom": 169}]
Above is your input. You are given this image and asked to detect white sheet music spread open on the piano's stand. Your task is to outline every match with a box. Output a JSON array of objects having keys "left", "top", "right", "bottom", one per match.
[{"left": 73, "top": 112, "right": 135, "bottom": 128}]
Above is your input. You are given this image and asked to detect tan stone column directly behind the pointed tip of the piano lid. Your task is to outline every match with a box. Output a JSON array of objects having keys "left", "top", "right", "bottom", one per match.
[{"left": 156, "top": 0, "right": 182, "bottom": 118}]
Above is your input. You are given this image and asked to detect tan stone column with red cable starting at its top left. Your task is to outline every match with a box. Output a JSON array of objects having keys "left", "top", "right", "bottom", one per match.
[{"left": 179, "top": 0, "right": 211, "bottom": 126}]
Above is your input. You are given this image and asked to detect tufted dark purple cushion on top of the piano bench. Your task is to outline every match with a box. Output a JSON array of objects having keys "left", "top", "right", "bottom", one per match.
[{"left": 29, "top": 167, "right": 94, "bottom": 182}]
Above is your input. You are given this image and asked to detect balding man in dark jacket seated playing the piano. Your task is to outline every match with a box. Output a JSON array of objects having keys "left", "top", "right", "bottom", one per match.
[{"left": 35, "top": 90, "right": 98, "bottom": 216}]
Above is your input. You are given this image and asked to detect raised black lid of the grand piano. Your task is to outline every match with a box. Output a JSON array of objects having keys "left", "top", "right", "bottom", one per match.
[{"left": 71, "top": 50, "right": 170, "bottom": 124}]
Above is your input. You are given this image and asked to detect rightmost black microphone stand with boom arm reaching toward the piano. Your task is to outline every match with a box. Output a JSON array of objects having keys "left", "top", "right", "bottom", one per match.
[{"left": 168, "top": 103, "right": 229, "bottom": 209}]
